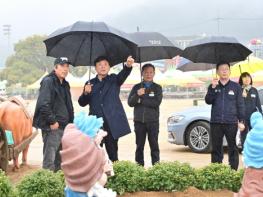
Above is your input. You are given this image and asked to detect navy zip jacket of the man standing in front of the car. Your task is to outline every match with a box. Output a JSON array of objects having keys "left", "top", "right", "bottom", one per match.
[{"left": 205, "top": 80, "right": 245, "bottom": 124}]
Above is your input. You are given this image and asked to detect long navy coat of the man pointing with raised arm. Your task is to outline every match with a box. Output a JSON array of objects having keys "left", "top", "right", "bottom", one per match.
[{"left": 78, "top": 66, "right": 132, "bottom": 139}]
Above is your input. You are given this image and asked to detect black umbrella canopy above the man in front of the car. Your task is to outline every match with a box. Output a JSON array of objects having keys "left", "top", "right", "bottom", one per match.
[{"left": 182, "top": 36, "right": 252, "bottom": 64}]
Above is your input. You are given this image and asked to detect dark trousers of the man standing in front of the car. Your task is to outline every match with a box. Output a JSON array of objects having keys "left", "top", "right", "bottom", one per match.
[{"left": 211, "top": 123, "right": 239, "bottom": 170}]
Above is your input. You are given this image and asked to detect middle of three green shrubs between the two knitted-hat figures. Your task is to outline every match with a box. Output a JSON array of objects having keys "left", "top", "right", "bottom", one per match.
[{"left": 146, "top": 162, "right": 195, "bottom": 191}]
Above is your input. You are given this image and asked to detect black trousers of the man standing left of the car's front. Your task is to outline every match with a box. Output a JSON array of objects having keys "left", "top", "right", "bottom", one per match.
[{"left": 134, "top": 121, "right": 160, "bottom": 166}]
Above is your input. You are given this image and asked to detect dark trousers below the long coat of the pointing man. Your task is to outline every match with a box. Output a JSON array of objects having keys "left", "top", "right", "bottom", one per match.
[{"left": 101, "top": 120, "right": 118, "bottom": 162}]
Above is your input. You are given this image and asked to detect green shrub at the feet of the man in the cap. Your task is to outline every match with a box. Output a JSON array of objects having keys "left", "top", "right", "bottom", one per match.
[{"left": 17, "top": 170, "right": 64, "bottom": 197}]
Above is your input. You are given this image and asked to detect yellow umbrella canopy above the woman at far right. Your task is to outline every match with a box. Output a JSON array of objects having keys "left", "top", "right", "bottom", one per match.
[{"left": 231, "top": 57, "right": 263, "bottom": 77}]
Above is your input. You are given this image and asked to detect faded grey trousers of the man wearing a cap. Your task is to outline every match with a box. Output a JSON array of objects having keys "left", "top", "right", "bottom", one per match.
[{"left": 42, "top": 129, "right": 64, "bottom": 172}]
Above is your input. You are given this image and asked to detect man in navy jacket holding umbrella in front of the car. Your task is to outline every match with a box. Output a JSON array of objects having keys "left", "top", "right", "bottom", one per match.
[{"left": 205, "top": 62, "right": 245, "bottom": 170}]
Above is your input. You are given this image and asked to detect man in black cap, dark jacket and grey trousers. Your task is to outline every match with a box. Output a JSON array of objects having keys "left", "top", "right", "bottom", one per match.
[{"left": 33, "top": 57, "right": 74, "bottom": 171}]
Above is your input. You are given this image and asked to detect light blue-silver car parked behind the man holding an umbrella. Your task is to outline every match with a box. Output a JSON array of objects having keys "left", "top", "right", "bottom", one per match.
[{"left": 167, "top": 87, "right": 263, "bottom": 153}]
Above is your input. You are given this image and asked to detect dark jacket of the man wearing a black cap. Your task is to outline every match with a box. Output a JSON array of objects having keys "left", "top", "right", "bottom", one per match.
[{"left": 33, "top": 71, "right": 74, "bottom": 131}]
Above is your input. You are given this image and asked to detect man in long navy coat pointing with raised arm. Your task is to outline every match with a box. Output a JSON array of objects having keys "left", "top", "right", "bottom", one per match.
[{"left": 78, "top": 56, "right": 134, "bottom": 161}]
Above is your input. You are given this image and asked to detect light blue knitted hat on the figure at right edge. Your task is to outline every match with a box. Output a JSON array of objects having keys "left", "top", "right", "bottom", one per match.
[{"left": 243, "top": 112, "right": 263, "bottom": 168}]
